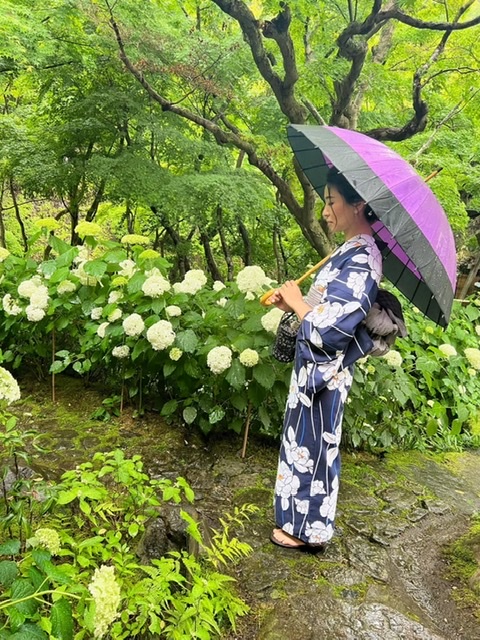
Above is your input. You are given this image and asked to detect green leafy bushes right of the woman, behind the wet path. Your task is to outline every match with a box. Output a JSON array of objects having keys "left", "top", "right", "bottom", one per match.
[{"left": 345, "top": 300, "right": 480, "bottom": 450}]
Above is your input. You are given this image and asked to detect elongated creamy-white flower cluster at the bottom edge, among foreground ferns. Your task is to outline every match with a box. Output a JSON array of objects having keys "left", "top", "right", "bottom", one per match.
[{"left": 88, "top": 565, "right": 121, "bottom": 640}]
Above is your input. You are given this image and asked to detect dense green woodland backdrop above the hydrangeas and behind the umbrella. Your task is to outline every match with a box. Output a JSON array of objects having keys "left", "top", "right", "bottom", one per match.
[{"left": 0, "top": 0, "right": 480, "bottom": 288}]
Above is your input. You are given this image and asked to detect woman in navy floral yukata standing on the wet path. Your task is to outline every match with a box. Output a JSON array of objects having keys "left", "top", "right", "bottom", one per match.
[{"left": 270, "top": 167, "right": 382, "bottom": 551}]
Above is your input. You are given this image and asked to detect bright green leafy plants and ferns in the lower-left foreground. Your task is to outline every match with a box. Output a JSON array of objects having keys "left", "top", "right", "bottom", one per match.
[{"left": 0, "top": 440, "right": 255, "bottom": 640}]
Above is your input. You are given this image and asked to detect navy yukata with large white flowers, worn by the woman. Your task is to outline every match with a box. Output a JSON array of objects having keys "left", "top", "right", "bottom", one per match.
[{"left": 275, "top": 235, "right": 382, "bottom": 544}]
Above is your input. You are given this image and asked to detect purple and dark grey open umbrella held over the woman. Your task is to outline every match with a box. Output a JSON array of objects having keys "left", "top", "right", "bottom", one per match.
[{"left": 288, "top": 125, "right": 456, "bottom": 327}]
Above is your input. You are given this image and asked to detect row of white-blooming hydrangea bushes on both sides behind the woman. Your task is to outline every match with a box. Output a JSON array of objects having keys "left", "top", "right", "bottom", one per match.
[{"left": 0, "top": 231, "right": 480, "bottom": 447}]
